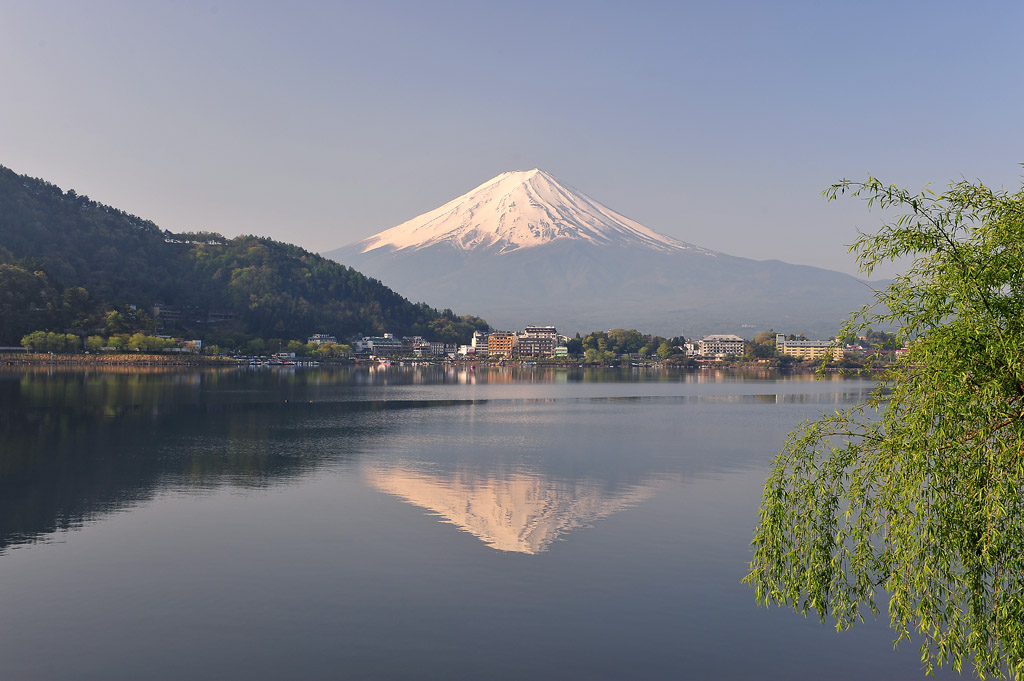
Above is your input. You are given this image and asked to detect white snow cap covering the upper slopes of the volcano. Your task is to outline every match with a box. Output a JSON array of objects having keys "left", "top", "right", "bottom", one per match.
[{"left": 359, "top": 168, "right": 694, "bottom": 253}]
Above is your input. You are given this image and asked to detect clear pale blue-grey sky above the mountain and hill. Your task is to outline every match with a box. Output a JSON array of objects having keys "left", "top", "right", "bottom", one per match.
[{"left": 0, "top": 0, "right": 1024, "bottom": 273}]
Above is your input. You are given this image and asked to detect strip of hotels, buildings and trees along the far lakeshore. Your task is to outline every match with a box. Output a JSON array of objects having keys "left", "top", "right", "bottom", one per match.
[{"left": 6, "top": 325, "right": 902, "bottom": 367}]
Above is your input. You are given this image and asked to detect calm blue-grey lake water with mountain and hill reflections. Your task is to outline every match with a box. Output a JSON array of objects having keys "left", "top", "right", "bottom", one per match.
[{"left": 0, "top": 367, "right": 958, "bottom": 681}]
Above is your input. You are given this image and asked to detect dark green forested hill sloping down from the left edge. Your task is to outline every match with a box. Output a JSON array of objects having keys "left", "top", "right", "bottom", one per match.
[{"left": 0, "top": 166, "right": 485, "bottom": 346}]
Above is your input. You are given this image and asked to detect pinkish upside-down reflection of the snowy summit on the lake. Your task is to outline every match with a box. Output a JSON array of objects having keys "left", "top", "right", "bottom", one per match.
[{"left": 365, "top": 465, "right": 654, "bottom": 554}]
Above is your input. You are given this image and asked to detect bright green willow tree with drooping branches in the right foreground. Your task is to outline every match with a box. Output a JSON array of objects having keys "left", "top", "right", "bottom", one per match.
[{"left": 745, "top": 178, "right": 1024, "bottom": 678}]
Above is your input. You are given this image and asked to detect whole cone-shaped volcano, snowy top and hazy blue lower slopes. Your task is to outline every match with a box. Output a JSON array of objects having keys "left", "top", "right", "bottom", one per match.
[{"left": 324, "top": 169, "right": 872, "bottom": 335}]
